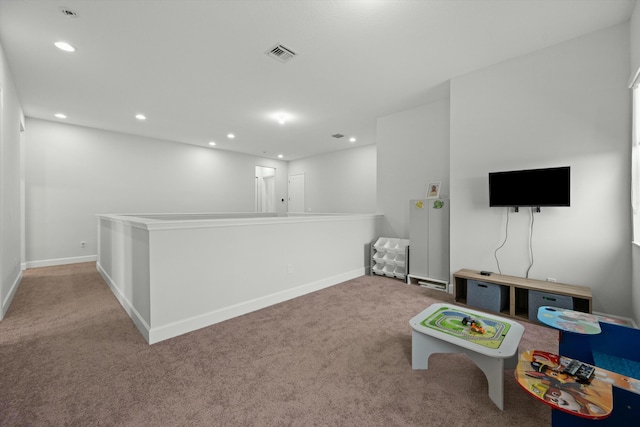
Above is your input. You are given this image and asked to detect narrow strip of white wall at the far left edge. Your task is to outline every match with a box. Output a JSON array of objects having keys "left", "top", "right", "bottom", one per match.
[{"left": 0, "top": 41, "right": 24, "bottom": 319}]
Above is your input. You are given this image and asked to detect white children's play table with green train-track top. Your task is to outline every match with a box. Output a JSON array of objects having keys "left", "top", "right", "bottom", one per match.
[{"left": 409, "top": 303, "right": 524, "bottom": 410}]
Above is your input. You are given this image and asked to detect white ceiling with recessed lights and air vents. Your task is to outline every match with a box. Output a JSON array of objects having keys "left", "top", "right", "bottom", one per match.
[{"left": 0, "top": 0, "right": 635, "bottom": 160}]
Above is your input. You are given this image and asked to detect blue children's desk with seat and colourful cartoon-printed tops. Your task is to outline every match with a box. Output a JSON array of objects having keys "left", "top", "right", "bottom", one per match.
[{"left": 516, "top": 306, "right": 640, "bottom": 427}]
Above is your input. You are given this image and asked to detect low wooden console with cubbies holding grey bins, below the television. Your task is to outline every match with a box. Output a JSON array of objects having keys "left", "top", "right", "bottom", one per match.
[{"left": 453, "top": 269, "right": 592, "bottom": 320}]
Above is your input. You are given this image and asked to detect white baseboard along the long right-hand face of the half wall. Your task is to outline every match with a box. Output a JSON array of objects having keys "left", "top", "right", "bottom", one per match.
[{"left": 146, "top": 268, "right": 366, "bottom": 344}]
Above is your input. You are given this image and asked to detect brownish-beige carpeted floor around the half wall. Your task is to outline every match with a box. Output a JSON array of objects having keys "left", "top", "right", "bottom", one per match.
[{"left": 0, "top": 263, "right": 557, "bottom": 427}]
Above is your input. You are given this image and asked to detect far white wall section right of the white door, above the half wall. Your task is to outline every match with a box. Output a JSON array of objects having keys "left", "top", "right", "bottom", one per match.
[{"left": 289, "top": 145, "right": 377, "bottom": 213}]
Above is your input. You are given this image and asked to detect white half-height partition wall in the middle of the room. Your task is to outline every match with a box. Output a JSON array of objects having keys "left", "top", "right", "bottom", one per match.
[{"left": 98, "top": 214, "right": 381, "bottom": 344}]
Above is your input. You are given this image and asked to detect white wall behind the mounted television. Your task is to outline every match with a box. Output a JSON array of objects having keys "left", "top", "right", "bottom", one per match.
[{"left": 451, "top": 24, "right": 632, "bottom": 316}]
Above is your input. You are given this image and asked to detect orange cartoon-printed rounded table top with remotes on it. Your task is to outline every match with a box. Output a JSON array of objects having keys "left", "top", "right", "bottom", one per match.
[{"left": 515, "top": 350, "right": 613, "bottom": 419}]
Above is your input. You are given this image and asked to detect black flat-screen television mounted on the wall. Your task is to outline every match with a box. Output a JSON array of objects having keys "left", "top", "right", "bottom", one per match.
[{"left": 489, "top": 166, "right": 571, "bottom": 207}]
